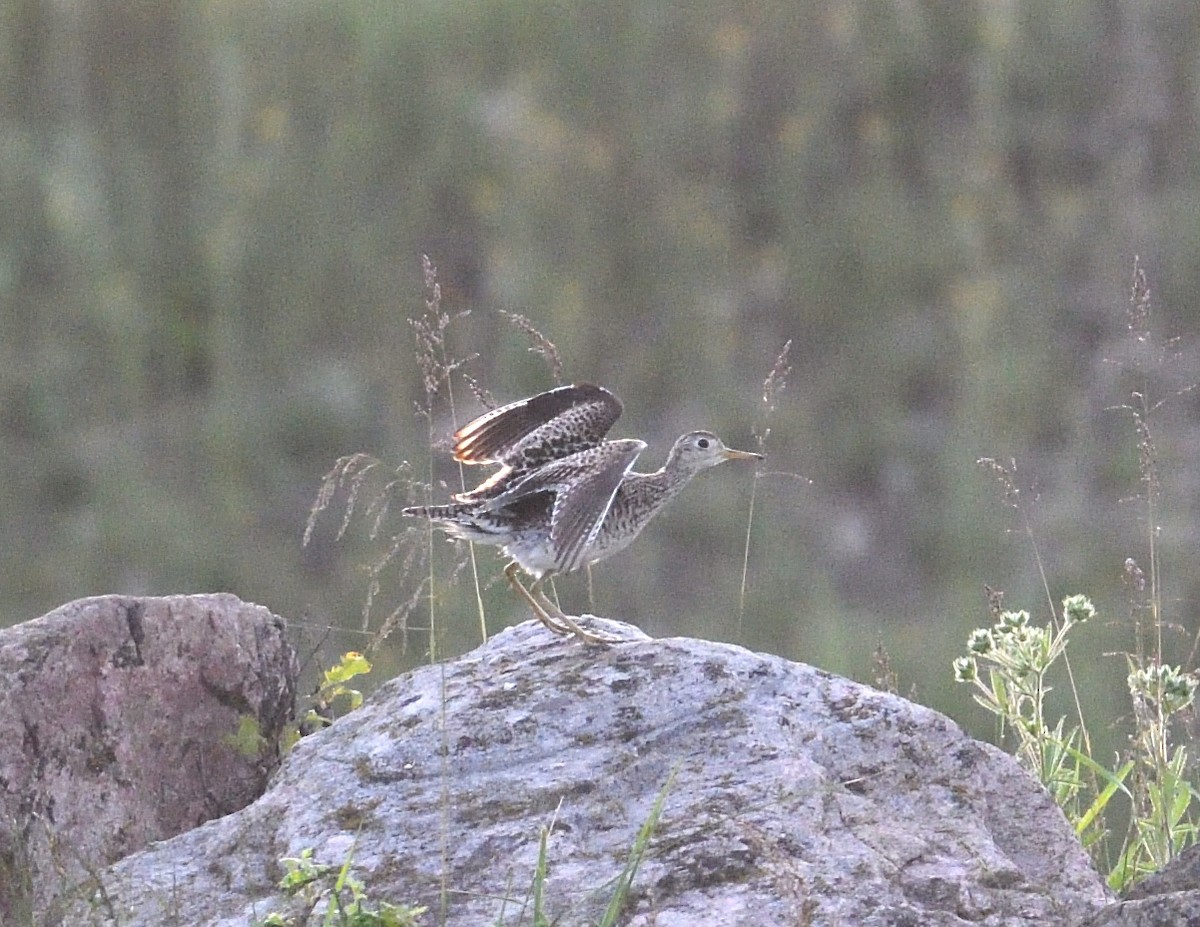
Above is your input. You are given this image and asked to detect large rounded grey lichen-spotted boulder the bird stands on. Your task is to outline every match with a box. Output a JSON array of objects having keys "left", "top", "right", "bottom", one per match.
[{"left": 64, "top": 620, "right": 1108, "bottom": 927}]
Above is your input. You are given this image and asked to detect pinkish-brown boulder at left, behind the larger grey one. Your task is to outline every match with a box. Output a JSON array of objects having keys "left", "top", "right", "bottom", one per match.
[{"left": 0, "top": 596, "right": 296, "bottom": 925}]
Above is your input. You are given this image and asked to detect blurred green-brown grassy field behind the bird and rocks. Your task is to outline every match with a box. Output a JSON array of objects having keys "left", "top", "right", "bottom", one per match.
[{"left": 0, "top": 0, "right": 1200, "bottom": 746}]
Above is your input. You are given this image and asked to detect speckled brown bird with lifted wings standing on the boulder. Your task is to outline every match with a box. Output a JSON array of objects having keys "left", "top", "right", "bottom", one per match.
[{"left": 402, "top": 383, "right": 762, "bottom": 644}]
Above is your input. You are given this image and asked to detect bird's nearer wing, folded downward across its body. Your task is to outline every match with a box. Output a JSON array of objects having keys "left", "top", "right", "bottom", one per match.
[{"left": 487, "top": 438, "right": 646, "bottom": 573}]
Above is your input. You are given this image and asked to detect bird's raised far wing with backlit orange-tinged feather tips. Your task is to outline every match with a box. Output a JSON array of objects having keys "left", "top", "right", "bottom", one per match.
[{"left": 454, "top": 383, "right": 622, "bottom": 502}]
